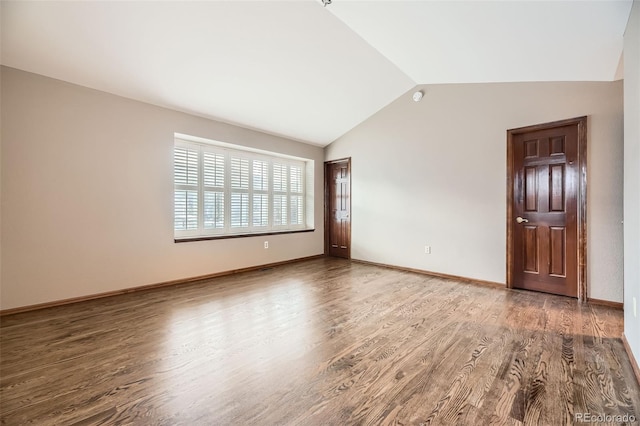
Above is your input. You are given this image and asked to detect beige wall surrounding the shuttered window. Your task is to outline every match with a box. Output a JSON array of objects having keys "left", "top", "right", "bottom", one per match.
[{"left": 0, "top": 68, "right": 323, "bottom": 309}]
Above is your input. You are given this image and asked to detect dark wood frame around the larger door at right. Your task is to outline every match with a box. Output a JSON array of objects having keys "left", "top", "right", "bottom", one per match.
[{"left": 507, "top": 116, "right": 587, "bottom": 302}]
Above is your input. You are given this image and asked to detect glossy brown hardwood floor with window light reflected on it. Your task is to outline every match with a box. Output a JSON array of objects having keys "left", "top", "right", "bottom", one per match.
[{"left": 0, "top": 258, "right": 640, "bottom": 425}]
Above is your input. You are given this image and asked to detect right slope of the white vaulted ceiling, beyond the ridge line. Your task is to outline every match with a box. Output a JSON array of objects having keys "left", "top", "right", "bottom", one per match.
[{"left": 331, "top": 0, "right": 632, "bottom": 83}]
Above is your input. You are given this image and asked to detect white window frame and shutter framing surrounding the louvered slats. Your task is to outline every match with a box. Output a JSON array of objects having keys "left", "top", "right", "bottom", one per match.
[{"left": 173, "top": 135, "right": 314, "bottom": 242}]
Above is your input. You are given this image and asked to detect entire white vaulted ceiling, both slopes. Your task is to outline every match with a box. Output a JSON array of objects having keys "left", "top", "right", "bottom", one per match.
[{"left": 1, "top": 0, "right": 632, "bottom": 146}]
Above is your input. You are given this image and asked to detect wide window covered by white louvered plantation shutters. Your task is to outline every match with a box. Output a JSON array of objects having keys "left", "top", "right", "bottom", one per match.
[{"left": 173, "top": 138, "right": 313, "bottom": 240}]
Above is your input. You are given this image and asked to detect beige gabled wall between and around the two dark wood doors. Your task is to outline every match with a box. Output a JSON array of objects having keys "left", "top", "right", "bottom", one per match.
[{"left": 325, "top": 82, "right": 623, "bottom": 302}]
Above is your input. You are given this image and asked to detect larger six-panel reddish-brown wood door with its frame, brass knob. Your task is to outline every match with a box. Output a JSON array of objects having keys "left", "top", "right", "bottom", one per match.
[{"left": 508, "top": 119, "right": 586, "bottom": 297}]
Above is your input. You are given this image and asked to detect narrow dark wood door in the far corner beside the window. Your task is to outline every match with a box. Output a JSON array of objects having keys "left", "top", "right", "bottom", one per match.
[{"left": 325, "top": 159, "right": 351, "bottom": 259}]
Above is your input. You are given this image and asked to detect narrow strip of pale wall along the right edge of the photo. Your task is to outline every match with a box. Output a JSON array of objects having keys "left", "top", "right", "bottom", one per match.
[{"left": 624, "top": 0, "right": 640, "bottom": 362}]
